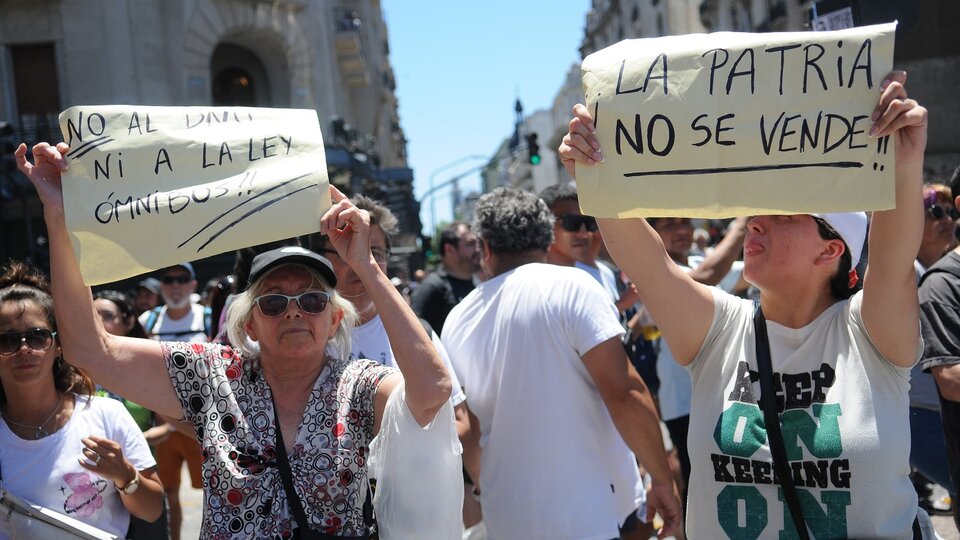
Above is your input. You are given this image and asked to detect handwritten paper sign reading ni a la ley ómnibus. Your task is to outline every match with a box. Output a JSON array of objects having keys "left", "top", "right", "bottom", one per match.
[{"left": 60, "top": 105, "right": 330, "bottom": 285}]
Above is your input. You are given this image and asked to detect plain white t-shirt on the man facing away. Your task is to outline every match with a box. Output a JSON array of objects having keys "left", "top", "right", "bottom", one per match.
[{"left": 443, "top": 264, "right": 642, "bottom": 539}]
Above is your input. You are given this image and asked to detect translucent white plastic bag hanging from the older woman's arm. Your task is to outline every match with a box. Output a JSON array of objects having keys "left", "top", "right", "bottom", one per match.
[{"left": 368, "top": 383, "right": 463, "bottom": 540}]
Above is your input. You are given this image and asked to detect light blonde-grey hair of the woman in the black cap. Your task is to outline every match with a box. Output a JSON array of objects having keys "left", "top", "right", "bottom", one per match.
[{"left": 226, "top": 264, "right": 359, "bottom": 360}]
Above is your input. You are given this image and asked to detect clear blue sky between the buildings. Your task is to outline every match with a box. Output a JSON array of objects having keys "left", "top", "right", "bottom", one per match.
[{"left": 382, "top": 0, "right": 591, "bottom": 235}]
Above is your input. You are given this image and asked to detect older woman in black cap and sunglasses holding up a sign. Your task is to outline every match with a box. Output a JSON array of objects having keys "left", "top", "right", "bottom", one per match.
[{"left": 15, "top": 138, "right": 451, "bottom": 539}]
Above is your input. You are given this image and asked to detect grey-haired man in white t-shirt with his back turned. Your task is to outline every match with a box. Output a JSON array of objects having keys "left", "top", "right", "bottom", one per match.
[{"left": 442, "top": 188, "right": 680, "bottom": 540}]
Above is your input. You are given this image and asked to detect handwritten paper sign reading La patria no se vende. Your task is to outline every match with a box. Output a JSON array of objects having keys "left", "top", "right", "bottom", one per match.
[{"left": 577, "top": 23, "right": 896, "bottom": 218}]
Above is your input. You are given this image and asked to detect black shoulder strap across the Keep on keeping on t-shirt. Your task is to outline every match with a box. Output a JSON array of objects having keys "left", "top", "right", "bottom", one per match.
[{"left": 753, "top": 302, "right": 810, "bottom": 540}]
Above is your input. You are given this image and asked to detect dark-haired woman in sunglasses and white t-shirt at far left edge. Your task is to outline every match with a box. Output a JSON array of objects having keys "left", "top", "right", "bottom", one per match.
[{"left": 0, "top": 262, "right": 163, "bottom": 538}]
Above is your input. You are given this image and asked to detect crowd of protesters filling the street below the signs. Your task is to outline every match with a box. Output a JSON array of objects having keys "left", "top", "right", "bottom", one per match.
[{"left": 0, "top": 67, "right": 960, "bottom": 540}]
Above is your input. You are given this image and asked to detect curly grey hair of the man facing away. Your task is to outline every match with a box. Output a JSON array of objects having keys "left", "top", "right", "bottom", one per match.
[{"left": 473, "top": 187, "right": 554, "bottom": 253}]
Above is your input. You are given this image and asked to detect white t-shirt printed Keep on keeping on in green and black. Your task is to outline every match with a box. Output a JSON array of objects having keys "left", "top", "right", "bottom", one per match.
[{"left": 687, "top": 289, "right": 922, "bottom": 539}]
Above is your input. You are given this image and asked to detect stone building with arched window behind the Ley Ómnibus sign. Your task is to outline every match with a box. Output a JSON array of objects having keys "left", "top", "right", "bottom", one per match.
[{"left": 0, "top": 0, "right": 420, "bottom": 274}]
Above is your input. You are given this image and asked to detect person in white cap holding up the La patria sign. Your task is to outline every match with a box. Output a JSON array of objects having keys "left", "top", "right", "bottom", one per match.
[{"left": 559, "top": 72, "right": 929, "bottom": 538}]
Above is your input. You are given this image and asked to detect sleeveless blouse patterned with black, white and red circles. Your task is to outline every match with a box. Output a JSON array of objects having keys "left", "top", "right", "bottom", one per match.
[{"left": 163, "top": 342, "right": 396, "bottom": 539}]
